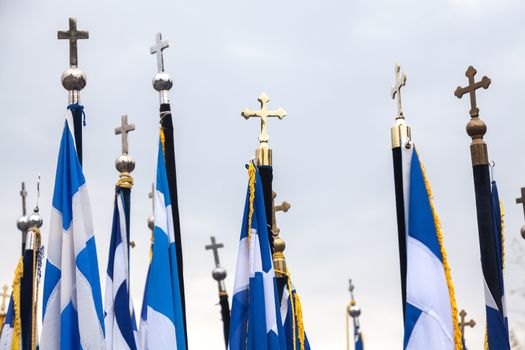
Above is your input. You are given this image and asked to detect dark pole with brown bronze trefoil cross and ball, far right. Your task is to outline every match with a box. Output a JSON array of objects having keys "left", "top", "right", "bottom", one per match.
[{"left": 454, "top": 66, "right": 509, "bottom": 349}]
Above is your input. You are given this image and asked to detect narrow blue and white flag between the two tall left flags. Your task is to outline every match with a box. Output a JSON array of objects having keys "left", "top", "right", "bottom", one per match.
[{"left": 104, "top": 186, "right": 138, "bottom": 350}]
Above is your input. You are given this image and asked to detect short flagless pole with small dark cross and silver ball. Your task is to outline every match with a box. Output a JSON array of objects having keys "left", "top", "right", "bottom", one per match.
[{"left": 204, "top": 236, "right": 230, "bottom": 348}]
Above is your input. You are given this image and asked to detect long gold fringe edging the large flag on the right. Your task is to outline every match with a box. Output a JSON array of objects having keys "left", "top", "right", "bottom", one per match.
[{"left": 416, "top": 150, "right": 463, "bottom": 350}]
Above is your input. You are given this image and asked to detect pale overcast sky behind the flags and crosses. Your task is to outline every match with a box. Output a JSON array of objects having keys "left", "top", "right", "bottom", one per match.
[{"left": 0, "top": 0, "right": 525, "bottom": 350}]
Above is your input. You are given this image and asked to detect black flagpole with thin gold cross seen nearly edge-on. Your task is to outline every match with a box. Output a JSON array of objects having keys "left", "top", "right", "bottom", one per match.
[{"left": 391, "top": 64, "right": 411, "bottom": 319}]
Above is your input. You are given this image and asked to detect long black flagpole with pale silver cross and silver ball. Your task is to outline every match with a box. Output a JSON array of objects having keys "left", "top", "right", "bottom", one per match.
[{"left": 150, "top": 33, "right": 188, "bottom": 346}]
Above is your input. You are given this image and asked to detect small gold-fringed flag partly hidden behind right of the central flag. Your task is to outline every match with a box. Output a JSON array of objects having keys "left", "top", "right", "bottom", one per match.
[{"left": 281, "top": 277, "right": 310, "bottom": 350}]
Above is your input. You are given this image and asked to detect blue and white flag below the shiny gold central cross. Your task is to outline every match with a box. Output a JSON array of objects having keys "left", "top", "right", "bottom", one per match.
[{"left": 228, "top": 163, "right": 286, "bottom": 350}]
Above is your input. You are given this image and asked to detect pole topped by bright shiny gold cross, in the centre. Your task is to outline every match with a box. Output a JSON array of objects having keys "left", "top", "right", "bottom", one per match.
[{"left": 241, "top": 92, "right": 286, "bottom": 253}]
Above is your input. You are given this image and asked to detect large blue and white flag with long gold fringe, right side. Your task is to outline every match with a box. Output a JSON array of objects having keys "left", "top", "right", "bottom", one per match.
[{"left": 402, "top": 143, "right": 461, "bottom": 350}]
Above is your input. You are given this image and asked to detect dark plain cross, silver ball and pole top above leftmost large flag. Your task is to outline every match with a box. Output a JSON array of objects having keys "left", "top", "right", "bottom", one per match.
[{"left": 57, "top": 17, "right": 89, "bottom": 164}]
